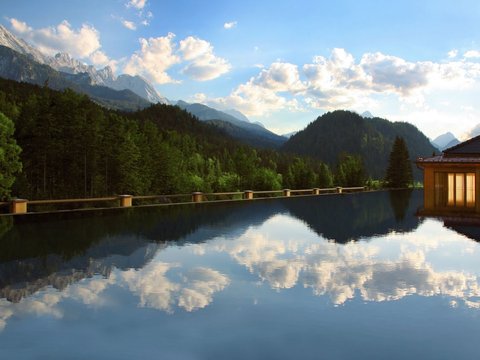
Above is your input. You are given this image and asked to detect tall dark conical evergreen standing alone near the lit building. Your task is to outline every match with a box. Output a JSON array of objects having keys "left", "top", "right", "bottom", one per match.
[{"left": 385, "top": 136, "right": 413, "bottom": 188}]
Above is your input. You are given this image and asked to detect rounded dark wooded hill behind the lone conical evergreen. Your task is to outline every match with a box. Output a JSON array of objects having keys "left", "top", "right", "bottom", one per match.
[{"left": 282, "top": 110, "right": 438, "bottom": 179}]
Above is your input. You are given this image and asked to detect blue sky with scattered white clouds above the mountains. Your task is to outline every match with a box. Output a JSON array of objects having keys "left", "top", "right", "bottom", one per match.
[{"left": 0, "top": 0, "right": 480, "bottom": 140}]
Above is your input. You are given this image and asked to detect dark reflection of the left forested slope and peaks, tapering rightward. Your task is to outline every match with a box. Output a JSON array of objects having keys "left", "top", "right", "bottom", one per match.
[{"left": 0, "top": 201, "right": 284, "bottom": 301}]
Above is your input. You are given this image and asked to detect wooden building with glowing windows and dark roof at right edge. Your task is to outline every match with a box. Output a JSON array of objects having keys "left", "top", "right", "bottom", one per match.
[{"left": 417, "top": 136, "right": 480, "bottom": 213}]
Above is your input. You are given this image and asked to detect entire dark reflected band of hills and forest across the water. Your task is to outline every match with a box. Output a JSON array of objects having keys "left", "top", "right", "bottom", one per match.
[{"left": 0, "top": 192, "right": 421, "bottom": 301}]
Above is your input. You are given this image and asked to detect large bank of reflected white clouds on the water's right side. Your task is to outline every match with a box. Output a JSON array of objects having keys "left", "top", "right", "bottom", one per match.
[{"left": 203, "top": 216, "right": 480, "bottom": 307}]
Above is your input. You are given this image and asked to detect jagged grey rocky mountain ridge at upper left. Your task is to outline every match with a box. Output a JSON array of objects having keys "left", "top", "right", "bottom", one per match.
[{"left": 0, "top": 25, "right": 169, "bottom": 104}]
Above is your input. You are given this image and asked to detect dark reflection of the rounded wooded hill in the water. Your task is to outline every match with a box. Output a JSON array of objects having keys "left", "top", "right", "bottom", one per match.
[{"left": 284, "top": 190, "right": 423, "bottom": 243}]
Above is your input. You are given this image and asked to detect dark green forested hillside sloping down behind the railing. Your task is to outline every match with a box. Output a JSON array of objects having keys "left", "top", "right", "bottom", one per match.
[{"left": 0, "top": 79, "right": 332, "bottom": 199}]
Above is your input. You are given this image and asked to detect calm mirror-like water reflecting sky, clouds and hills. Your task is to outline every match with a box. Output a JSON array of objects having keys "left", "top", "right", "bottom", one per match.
[{"left": 0, "top": 191, "right": 480, "bottom": 359}]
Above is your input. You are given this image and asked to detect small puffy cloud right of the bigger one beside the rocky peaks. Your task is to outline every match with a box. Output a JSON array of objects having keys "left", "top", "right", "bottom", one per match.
[{"left": 179, "top": 36, "right": 231, "bottom": 81}]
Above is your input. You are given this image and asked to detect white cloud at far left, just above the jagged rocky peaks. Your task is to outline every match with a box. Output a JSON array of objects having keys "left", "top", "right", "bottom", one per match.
[{"left": 10, "top": 19, "right": 101, "bottom": 58}]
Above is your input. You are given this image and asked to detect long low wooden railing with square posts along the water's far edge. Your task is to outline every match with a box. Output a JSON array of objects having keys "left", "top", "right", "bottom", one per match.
[{"left": 0, "top": 186, "right": 365, "bottom": 214}]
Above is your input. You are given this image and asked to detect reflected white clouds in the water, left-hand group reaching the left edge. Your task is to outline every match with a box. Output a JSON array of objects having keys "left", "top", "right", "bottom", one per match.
[{"left": 0, "top": 262, "right": 230, "bottom": 331}]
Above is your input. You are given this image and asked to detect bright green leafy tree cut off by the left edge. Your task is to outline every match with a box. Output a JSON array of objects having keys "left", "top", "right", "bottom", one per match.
[{"left": 0, "top": 112, "right": 22, "bottom": 200}]
